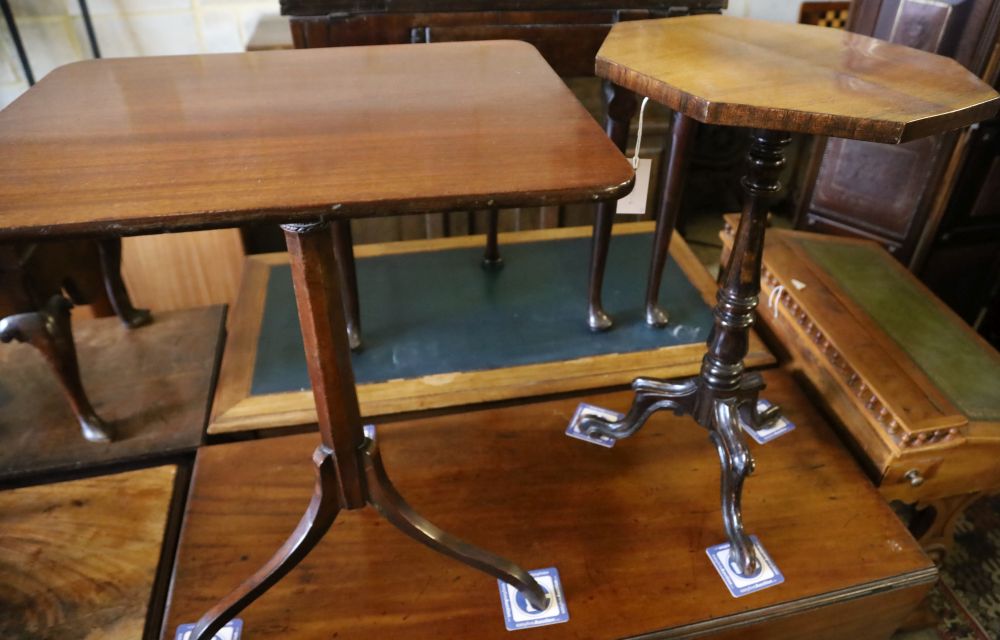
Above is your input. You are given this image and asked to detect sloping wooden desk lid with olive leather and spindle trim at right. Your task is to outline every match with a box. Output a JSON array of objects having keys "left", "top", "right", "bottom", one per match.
[{"left": 723, "top": 216, "right": 1000, "bottom": 456}]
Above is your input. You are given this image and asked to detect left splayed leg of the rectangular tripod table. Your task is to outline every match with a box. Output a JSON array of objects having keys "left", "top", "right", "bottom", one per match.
[{"left": 191, "top": 445, "right": 340, "bottom": 640}]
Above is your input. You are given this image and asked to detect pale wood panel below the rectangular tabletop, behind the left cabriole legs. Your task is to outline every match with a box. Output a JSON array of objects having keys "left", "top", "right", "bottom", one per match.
[{"left": 122, "top": 229, "right": 244, "bottom": 311}]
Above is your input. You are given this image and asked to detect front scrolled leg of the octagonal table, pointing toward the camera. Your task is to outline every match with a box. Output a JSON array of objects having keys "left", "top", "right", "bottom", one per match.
[{"left": 711, "top": 398, "right": 760, "bottom": 576}]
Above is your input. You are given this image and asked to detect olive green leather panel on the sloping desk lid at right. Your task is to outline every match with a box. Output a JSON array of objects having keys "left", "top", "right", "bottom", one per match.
[{"left": 794, "top": 238, "right": 1000, "bottom": 420}]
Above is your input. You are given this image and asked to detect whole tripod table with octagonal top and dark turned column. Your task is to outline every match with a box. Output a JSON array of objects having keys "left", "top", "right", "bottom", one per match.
[{"left": 580, "top": 15, "right": 1000, "bottom": 575}]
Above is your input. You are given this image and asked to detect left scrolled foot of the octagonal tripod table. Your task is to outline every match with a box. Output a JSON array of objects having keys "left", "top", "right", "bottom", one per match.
[{"left": 580, "top": 378, "right": 698, "bottom": 440}]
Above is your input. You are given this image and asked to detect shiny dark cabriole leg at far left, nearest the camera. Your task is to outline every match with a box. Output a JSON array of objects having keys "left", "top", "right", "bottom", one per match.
[{"left": 0, "top": 295, "right": 114, "bottom": 442}]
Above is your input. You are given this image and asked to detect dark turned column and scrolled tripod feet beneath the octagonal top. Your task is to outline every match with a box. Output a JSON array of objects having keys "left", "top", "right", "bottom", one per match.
[{"left": 580, "top": 130, "right": 791, "bottom": 575}]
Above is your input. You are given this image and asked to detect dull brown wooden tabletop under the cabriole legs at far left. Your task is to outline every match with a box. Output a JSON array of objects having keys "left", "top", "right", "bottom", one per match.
[{"left": 0, "top": 307, "right": 225, "bottom": 484}]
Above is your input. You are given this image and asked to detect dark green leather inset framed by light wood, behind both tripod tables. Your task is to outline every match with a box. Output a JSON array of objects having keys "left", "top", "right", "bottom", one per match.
[{"left": 251, "top": 234, "right": 712, "bottom": 395}]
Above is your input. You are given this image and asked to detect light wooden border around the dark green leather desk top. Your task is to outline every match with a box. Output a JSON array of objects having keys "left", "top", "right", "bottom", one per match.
[{"left": 208, "top": 222, "right": 774, "bottom": 434}]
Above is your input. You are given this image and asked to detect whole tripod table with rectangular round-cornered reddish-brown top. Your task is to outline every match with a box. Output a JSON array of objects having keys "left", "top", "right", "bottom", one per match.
[{"left": 0, "top": 42, "right": 633, "bottom": 640}]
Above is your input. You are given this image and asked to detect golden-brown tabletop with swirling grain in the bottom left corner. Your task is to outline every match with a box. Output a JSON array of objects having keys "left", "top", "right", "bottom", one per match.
[{"left": 0, "top": 466, "right": 177, "bottom": 640}]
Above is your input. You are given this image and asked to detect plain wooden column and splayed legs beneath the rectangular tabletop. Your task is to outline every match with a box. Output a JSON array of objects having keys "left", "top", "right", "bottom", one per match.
[{"left": 192, "top": 222, "right": 549, "bottom": 640}]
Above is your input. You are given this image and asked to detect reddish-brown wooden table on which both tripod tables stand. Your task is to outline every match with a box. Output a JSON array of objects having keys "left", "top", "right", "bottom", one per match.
[{"left": 164, "top": 372, "right": 935, "bottom": 640}]
